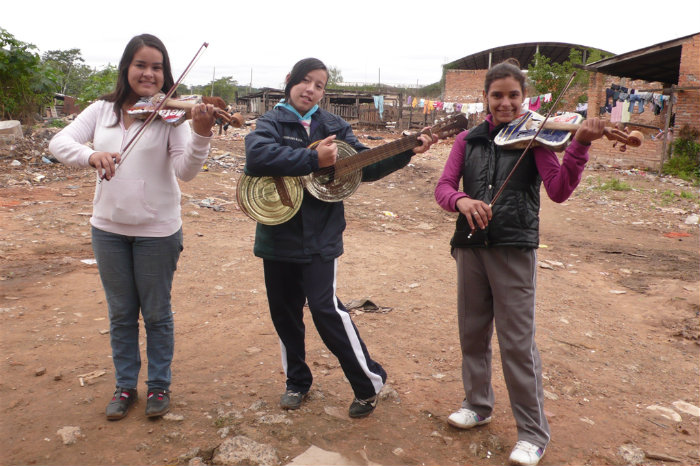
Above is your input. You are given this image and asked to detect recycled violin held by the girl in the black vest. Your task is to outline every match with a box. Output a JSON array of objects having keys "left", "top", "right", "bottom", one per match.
[{"left": 494, "top": 111, "right": 644, "bottom": 152}]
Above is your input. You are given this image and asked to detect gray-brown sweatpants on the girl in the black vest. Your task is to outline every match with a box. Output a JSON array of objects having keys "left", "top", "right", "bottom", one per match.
[{"left": 453, "top": 247, "right": 549, "bottom": 448}]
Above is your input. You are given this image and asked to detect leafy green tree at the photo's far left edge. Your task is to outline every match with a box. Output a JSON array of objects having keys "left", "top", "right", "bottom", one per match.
[{"left": 0, "top": 28, "right": 56, "bottom": 123}]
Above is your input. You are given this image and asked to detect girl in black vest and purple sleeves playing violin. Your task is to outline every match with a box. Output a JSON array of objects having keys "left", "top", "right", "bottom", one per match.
[{"left": 435, "top": 62, "right": 604, "bottom": 466}]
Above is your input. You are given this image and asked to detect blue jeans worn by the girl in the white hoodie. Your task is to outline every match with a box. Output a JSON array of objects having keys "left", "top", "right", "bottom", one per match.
[{"left": 92, "top": 227, "right": 182, "bottom": 391}]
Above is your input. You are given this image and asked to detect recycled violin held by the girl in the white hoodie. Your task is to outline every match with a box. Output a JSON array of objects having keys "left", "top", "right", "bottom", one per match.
[{"left": 126, "top": 93, "right": 245, "bottom": 128}]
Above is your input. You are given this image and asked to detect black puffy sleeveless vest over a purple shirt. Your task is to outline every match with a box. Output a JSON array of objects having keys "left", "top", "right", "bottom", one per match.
[{"left": 450, "top": 122, "right": 542, "bottom": 248}]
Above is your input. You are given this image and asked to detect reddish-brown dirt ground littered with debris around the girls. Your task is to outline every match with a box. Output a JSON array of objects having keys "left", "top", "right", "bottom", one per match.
[{"left": 0, "top": 124, "right": 700, "bottom": 465}]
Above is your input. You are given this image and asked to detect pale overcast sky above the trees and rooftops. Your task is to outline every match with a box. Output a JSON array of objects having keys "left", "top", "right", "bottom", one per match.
[{"left": 0, "top": 0, "right": 700, "bottom": 88}]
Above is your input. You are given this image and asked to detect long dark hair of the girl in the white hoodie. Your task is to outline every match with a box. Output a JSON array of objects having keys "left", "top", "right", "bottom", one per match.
[{"left": 100, "top": 34, "right": 177, "bottom": 125}]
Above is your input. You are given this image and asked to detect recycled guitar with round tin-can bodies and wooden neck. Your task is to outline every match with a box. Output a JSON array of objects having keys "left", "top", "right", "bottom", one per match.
[{"left": 236, "top": 113, "right": 467, "bottom": 225}]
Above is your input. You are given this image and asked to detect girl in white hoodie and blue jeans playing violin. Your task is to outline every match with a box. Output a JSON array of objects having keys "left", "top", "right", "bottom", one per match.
[{"left": 49, "top": 34, "right": 214, "bottom": 420}]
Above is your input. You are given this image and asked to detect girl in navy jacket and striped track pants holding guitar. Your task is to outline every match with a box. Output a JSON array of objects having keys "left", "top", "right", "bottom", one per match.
[{"left": 245, "top": 58, "right": 437, "bottom": 418}]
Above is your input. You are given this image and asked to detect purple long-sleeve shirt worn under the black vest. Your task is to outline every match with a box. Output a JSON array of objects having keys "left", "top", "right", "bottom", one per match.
[{"left": 435, "top": 115, "right": 590, "bottom": 212}]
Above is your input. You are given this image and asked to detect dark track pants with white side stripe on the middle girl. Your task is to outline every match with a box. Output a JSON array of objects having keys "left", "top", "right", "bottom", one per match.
[{"left": 263, "top": 256, "right": 386, "bottom": 399}]
